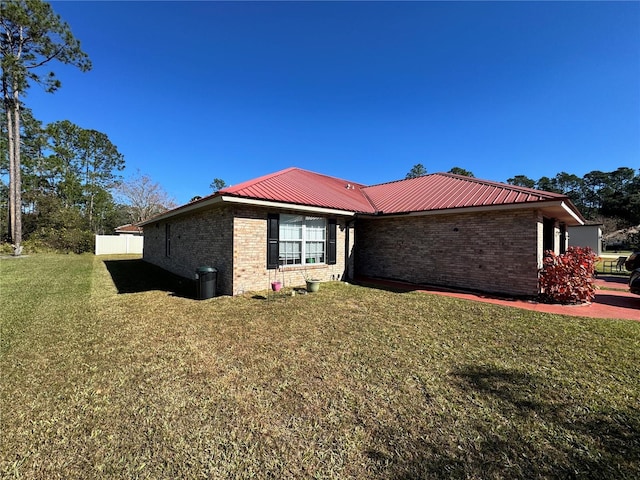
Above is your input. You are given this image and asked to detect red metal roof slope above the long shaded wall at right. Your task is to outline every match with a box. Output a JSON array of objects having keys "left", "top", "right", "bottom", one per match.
[{"left": 363, "top": 173, "right": 567, "bottom": 213}]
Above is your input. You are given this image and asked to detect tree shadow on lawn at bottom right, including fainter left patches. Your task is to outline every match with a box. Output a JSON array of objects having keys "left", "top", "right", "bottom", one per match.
[{"left": 367, "top": 366, "right": 640, "bottom": 479}]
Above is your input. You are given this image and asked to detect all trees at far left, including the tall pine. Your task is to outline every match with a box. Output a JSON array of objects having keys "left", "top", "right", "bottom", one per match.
[{"left": 0, "top": 0, "right": 173, "bottom": 255}]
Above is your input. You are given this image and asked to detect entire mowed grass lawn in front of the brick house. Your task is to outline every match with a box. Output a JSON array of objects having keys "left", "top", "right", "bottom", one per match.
[{"left": 0, "top": 255, "right": 640, "bottom": 479}]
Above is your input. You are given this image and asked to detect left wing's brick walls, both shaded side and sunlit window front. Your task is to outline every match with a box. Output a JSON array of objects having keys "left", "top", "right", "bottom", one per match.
[{"left": 143, "top": 205, "right": 354, "bottom": 295}]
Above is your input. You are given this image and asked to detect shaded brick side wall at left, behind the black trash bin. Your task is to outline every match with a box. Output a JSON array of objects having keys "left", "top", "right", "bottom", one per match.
[{"left": 143, "top": 206, "right": 233, "bottom": 295}]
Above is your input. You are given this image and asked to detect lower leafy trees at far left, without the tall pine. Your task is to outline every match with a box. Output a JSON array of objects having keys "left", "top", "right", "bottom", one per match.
[{"left": 0, "top": 107, "right": 175, "bottom": 252}]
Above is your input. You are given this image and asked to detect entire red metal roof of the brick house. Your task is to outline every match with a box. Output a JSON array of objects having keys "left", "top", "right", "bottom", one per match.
[{"left": 142, "top": 167, "right": 582, "bottom": 225}]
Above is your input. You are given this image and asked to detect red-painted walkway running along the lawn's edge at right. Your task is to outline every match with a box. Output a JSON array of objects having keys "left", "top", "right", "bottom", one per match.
[{"left": 360, "top": 275, "right": 640, "bottom": 321}]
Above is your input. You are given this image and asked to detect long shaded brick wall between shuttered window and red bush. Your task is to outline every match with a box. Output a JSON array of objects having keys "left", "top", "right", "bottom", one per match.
[{"left": 356, "top": 210, "right": 541, "bottom": 295}]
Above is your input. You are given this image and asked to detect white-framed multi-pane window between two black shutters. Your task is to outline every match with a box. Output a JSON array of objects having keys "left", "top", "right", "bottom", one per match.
[{"left": 278, "top": 215, "right": 327, "bottom": 265}]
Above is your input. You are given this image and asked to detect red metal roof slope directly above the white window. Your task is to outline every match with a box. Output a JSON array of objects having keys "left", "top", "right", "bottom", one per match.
[{"left": 219, "top": 168, "right": 375, "bottom": 213}]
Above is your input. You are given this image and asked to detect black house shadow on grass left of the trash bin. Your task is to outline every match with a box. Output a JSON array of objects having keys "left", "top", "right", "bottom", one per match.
[{"left": 104, "top": 259, "right": 196, "bottom": 299}]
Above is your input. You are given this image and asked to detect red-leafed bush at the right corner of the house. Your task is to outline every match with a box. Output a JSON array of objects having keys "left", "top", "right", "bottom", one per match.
[{"left": 540, "top": 247, "right": 597, "bottom": 304}]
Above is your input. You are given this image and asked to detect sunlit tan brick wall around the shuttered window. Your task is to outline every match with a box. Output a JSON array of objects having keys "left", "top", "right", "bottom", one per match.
[{"left": 233, "top": 207, "right": 354, "bottom": 295}]
